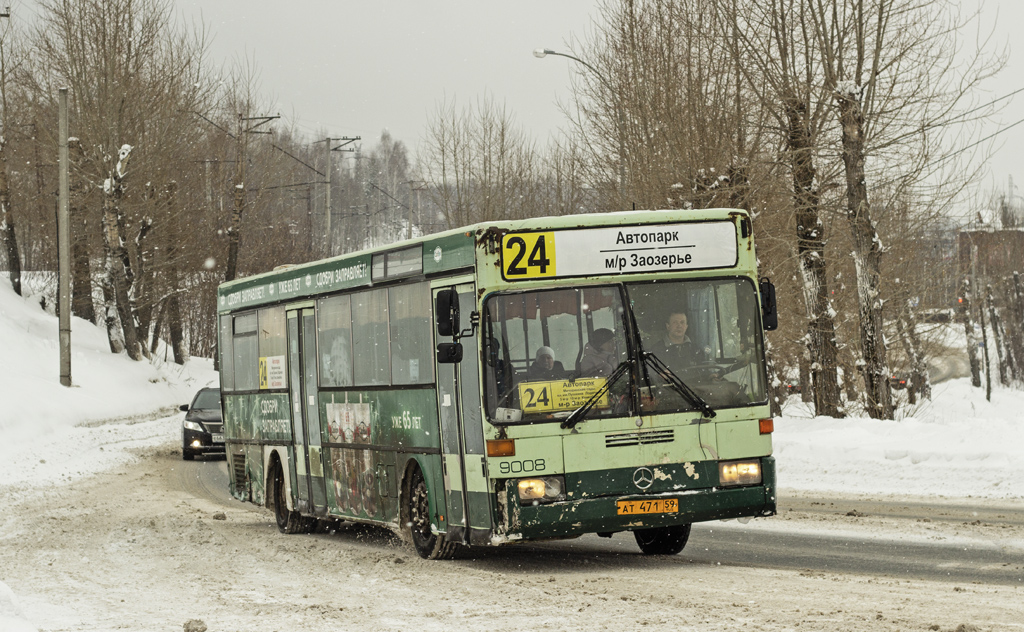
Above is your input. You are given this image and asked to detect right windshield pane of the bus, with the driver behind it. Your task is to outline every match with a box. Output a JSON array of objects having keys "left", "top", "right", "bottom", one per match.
[{"left": 628, "top": 279, "right": 767, "bottom": 414}]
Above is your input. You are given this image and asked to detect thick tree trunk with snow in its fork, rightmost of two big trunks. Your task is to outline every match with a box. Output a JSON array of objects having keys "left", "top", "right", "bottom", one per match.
[{"left": 837, "top": 93, "right": 893, "bottom": 419}]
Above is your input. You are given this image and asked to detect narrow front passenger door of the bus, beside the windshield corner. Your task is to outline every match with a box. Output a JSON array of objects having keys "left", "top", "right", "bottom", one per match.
[{"left": 434, "top": 284, "right": 490, "bottom": 544}]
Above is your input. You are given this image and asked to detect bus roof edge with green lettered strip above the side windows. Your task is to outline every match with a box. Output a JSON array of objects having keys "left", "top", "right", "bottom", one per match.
[{"left": 217, "top": 209, "right": 749, "bottom": 312}]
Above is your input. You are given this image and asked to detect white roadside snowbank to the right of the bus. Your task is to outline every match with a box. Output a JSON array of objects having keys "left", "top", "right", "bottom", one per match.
[{"left": 774, "top": 378, "right": 1024, "bottom": 499}]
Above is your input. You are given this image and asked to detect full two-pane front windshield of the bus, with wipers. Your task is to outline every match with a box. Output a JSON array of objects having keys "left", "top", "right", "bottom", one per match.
[{"left": 482, "top": 279, "right": 765, "bottom": 423}]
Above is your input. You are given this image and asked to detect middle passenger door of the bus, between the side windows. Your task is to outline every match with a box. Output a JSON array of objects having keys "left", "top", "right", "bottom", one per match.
[{"left": 288, "top": 308, "right": 327, "bottom": 516}]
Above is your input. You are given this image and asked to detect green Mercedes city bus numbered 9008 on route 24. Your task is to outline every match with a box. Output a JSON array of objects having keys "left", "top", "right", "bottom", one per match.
[{"left": 218, "top": 209, "right": 776, "bottom": 559}]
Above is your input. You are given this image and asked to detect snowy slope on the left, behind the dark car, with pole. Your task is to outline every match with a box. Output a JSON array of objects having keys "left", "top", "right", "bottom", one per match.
[{"left": 0, "top": 279, "right": 217, "bottom": 498}]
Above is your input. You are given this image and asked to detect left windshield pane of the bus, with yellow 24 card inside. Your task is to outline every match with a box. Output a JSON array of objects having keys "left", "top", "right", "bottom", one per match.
[{"left": 482, "top": 286, "right": 631, "bottom": 422}]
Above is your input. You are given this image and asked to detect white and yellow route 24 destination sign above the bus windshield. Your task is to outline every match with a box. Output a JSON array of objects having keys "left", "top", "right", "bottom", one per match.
[{"left": 502, "top": 221, "right": 738, "bottom": 281}]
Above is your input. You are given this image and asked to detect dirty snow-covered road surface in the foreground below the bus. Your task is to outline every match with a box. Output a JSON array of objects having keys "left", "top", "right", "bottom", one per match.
[{"left": 0, "top": 445, "right": 1024, "bottom": 632}]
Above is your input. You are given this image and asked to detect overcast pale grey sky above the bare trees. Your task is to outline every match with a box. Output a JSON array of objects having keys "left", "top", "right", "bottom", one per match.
[{"left": 186, "top": 0, "right": 1024, "bottom": 201}]
